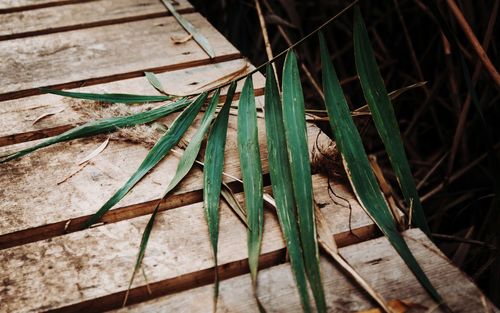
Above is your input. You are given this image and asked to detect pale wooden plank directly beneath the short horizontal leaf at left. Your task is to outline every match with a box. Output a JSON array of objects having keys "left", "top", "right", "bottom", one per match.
[{"left": 0, "top": 59, "right": 265, "bottom": 146}]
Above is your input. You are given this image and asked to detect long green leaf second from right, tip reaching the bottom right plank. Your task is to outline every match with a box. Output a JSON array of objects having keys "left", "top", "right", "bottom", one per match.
[{"left": 320, "top": 31, "right": 443, "bottom": 303}]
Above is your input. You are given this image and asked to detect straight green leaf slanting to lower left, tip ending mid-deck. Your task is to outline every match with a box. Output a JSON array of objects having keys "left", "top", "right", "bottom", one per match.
[{"left": 84, "top": 93, "right": 207, "bottom": 228}]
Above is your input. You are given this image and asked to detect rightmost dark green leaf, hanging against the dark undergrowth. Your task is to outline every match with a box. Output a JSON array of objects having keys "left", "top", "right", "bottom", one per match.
[{"left": 354, "top": 8, "right": 431, "bottom": 236}]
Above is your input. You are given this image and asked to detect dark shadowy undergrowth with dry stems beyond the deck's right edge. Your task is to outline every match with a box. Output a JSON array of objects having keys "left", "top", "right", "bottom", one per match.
[{"left": 192, "top": 0, "right": 500, "bottom": 305}]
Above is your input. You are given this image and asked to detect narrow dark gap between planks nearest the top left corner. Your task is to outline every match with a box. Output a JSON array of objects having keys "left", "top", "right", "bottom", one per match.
[{"left": 0, "top": 7, "right": 196, "bottom": 41}]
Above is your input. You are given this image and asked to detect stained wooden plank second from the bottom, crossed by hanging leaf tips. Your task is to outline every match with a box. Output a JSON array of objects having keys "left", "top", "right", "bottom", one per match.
[{"left": 0, "top": 172, "right": 372, "bottom": 312}]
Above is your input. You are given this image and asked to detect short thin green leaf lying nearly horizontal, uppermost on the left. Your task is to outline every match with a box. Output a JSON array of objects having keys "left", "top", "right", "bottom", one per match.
[{"left": 40, "top": 88, "right": 172, "bottom": 103}]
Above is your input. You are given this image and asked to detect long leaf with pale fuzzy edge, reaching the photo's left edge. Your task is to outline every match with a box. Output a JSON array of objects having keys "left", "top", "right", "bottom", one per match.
[{"left": 0, "top": 98, "right": 190, "bottom": 163}]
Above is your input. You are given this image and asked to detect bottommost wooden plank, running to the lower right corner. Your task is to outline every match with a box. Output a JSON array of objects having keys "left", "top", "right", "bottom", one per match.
[{"left": 113, "top": 230, "right": 498, "bottom": 313}]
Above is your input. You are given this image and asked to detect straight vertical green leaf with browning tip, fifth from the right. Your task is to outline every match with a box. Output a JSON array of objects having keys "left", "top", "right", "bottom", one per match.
[{"left": 237, "top": 76, "right": 264, "bottom": 290}]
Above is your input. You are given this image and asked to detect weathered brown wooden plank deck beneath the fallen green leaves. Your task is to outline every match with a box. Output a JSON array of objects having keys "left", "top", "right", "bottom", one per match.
[{"left": 0, "top": 0, "right": 497, "bottom": 312}]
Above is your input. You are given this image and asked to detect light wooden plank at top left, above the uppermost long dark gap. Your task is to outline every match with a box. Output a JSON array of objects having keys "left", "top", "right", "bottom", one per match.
[{"left": 0, "top": 0, "right": 194, "bottom": 40}]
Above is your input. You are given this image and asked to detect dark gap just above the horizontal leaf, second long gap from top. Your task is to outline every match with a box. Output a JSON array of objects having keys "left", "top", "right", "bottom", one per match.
[{"left": 0, "top": 52, "right": 241, "bottom": 101}]
